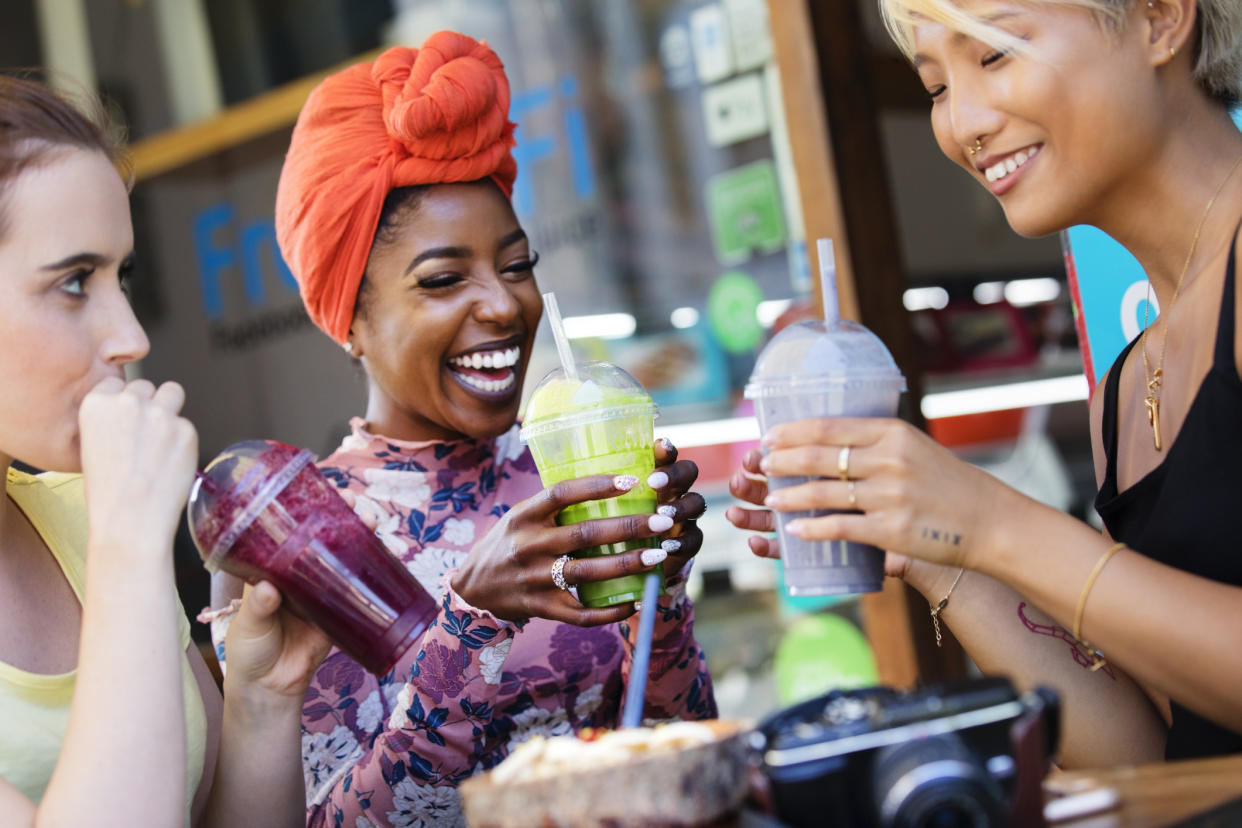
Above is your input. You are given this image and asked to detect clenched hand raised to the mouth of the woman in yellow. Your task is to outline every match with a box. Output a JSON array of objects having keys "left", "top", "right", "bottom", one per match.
[{"left": 78, "top": 377, "right": 199, "bottom": 552}]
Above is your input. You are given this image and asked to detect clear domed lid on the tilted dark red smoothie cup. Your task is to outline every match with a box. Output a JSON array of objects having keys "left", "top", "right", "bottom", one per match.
[{"left": 185, "top": 439, "right": 314, "bottom": 572}]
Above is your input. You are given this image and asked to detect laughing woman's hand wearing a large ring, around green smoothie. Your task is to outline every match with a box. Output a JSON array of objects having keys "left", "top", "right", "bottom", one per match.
[{"left": 452, "top": 474, "right": 673, "bottom": 627}]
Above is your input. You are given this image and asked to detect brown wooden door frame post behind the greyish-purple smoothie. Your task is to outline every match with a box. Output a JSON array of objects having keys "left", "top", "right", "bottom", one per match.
[{"left": 768, "top": 0, "right": 966, "bottom": 688}]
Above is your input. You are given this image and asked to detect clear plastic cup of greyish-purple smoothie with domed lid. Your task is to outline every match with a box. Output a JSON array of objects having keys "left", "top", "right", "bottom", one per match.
[{"left": 745, "top": 319, "right": 905, "bottom": 596}]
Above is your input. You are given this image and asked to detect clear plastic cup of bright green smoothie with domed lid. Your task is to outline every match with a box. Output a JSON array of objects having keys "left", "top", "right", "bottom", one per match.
[{"left": 522, "top": 362, "right": 664, "bottom": 607}]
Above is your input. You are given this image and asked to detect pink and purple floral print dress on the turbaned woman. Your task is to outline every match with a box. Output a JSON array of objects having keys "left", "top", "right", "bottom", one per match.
[{"left": 302, "top": 418, "right": 717, "bottom": 828}]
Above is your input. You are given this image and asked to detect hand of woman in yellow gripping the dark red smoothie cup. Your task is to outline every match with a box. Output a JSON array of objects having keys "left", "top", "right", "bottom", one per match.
[{"left": 225, "top": 581, "right": 332, "bottom": 708}]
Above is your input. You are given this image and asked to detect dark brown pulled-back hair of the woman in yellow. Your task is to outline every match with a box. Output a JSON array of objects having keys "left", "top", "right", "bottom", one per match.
[{"left": 0, "top": 70, "right": 130, "bottom": 236}]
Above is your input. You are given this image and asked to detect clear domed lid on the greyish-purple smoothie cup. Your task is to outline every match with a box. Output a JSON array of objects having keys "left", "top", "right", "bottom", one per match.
[{"left": 745, "top": 319, "right": 905, "bottom": 400}]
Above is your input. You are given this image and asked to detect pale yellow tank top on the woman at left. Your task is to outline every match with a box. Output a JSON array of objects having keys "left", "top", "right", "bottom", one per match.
[{"left": 0, "top": 469, "right": 207, "bottom": 824}]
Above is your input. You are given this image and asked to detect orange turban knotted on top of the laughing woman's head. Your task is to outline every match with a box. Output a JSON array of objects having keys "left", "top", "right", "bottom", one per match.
[{"left": 276, "top": 31, "right": 518, "bottom": 344}]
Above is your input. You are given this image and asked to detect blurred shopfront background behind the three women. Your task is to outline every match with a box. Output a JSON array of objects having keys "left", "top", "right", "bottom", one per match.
[{"left": 7, "top": 0, "right": 1095, "bottom": 716}]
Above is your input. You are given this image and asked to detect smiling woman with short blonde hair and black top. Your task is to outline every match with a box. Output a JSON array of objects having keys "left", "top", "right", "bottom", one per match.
[{"left": 729, "top": 0, "right": 1242, "bottom": 766}]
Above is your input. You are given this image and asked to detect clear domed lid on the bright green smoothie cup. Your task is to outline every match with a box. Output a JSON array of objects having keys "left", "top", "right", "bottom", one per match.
[{"left": 522, "top": 361, "right": 656, "bottom": 439}]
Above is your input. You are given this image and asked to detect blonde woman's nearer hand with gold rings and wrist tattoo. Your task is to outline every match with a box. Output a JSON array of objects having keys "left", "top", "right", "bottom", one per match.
[{"left": 760, "top": 417, "right": 1017, "bottom": 574}]
